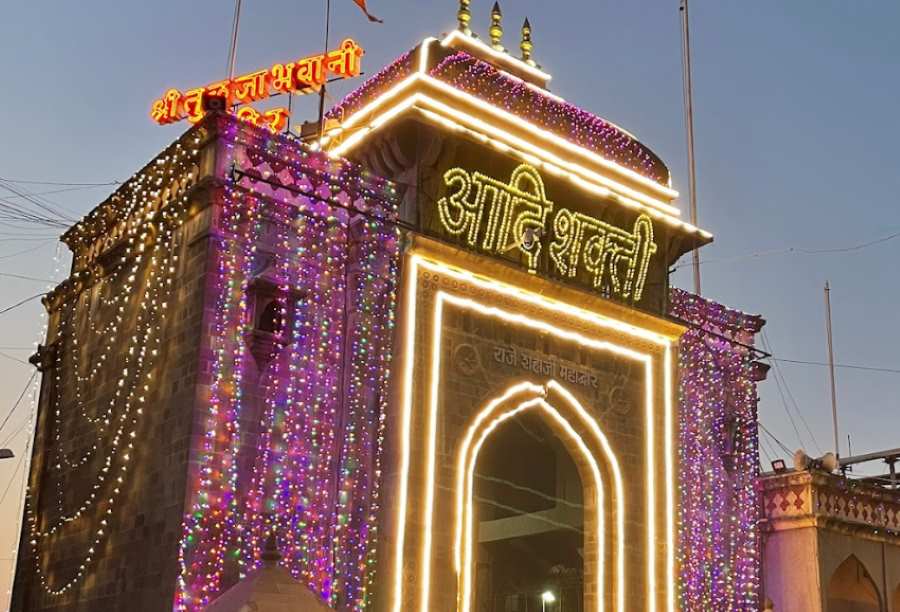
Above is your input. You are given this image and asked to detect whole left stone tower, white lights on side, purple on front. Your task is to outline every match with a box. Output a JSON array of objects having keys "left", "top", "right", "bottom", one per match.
[{"left": 13, "top": 116, "right": 398, "bottom": 611}]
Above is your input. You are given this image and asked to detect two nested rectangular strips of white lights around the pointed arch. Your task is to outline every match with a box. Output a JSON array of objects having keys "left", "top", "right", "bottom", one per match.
[{"left": 391, "top": 251, "right": 677, "bottom": 612}]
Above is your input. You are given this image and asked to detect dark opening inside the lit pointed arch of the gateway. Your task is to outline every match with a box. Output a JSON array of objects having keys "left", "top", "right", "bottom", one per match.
[{"left": 472, "top": 411, "right": 585, "bottom": 612}]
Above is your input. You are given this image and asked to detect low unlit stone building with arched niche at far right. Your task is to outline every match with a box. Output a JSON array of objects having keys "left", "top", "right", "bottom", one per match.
[{"left": 761, "top": 451, "right": 900, "bottom": 612}]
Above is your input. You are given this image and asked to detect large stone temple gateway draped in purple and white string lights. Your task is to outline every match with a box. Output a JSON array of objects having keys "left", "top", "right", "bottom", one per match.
[{"left": 13, "top": 8, "right": 764, "bottom": 612}]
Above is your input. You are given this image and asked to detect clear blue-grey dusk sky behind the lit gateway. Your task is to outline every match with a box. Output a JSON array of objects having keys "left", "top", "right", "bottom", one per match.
[{"left": 0, "top": 0, "right": 900, "bottom": 605}]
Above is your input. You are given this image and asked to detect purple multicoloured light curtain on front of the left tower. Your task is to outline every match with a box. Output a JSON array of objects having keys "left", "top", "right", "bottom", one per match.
[{"left": 173, "top": 117, "right": 400, "bottom": 612}]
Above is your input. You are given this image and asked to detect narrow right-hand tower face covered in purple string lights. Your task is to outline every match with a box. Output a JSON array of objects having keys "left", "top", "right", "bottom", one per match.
[{"left": 669, "top": 289, "right": 765, "bottom": 612}]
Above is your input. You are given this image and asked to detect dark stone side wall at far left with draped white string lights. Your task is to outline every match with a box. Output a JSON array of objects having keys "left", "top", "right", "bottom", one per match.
[{"left": 12, "top": 120, "right": 220, "bottom": 612}]
